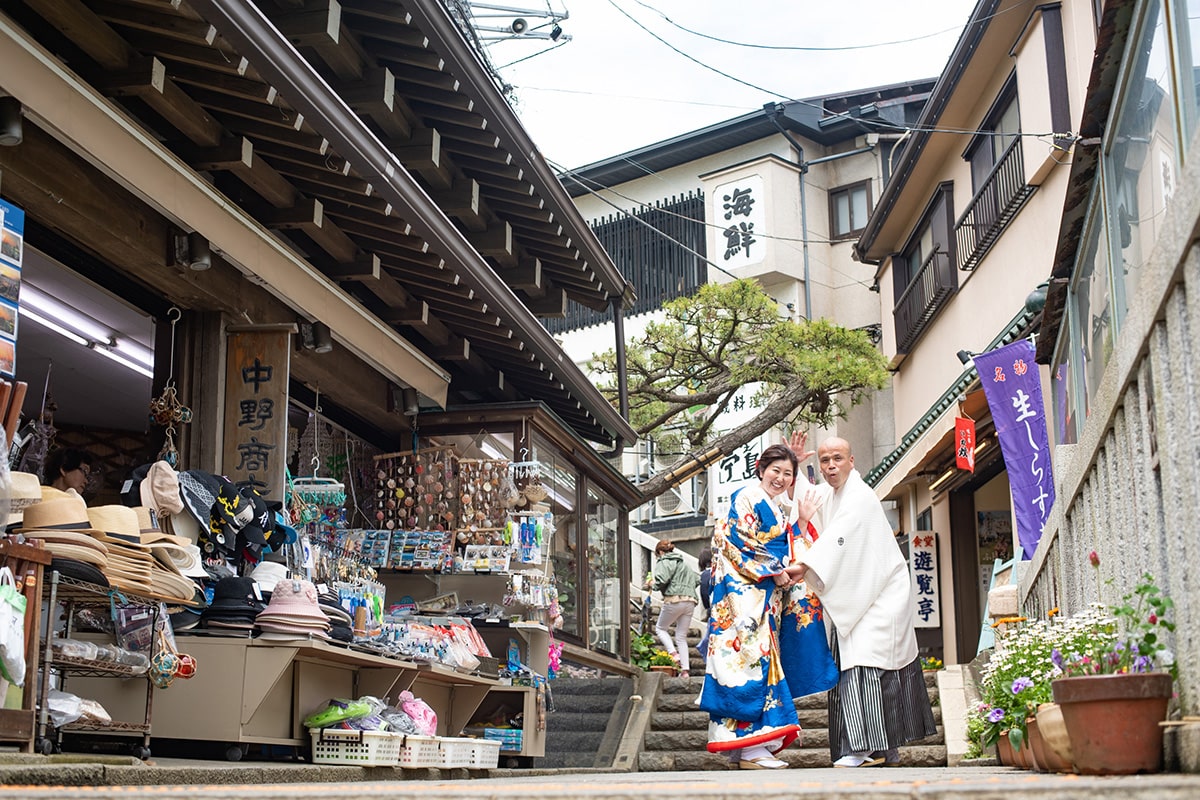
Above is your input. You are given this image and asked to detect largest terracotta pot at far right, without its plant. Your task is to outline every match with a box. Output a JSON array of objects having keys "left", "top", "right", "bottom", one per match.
[{"left": 1051, "top": 673, "right": 1172, "bottom": 775}]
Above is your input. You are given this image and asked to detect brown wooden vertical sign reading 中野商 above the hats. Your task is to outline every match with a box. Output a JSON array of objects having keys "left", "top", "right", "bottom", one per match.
[{"left": 222, "top": 324, "right": 295, "bottom": 500}]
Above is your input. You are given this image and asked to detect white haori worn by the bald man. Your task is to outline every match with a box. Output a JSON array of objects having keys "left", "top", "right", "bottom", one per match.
[{"left": 803, "top": 470, "right": 917, "bottom": 672}]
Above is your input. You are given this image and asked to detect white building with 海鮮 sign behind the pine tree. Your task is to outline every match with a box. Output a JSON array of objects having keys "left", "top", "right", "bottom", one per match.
[{"left": 547, "top": 82, "right": 932, "bottom": 553}]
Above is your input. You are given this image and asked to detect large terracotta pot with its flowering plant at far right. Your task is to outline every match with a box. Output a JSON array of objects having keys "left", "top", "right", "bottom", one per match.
[{"left": 1051, "top": 552, "right": 1177, "bottom": 775}]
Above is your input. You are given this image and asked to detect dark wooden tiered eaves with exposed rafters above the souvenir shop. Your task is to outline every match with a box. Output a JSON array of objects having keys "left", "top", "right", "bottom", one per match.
[{"left": 2, "top": 0, "right": 634, "bottom": 443}]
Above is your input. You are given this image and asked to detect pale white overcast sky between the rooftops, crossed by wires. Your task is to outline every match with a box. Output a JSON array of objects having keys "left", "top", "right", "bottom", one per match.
[{"left": 475, "top": 0, "right": 974, "bottom": 168}]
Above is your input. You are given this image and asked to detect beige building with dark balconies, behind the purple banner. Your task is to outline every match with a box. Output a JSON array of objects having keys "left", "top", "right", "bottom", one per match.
[{"left": 854, "top": 0, "right": 1094, "bottom": 663}]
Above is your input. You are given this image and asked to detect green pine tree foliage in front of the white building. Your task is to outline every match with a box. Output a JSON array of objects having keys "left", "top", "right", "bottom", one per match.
[{"left": 595, "top": 279, "right": 888, "bottom": 452}]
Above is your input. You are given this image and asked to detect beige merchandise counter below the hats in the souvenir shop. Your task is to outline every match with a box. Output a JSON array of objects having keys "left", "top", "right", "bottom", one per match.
[{"left": 70, "top": 636, "right": 520, "bottom": 760}]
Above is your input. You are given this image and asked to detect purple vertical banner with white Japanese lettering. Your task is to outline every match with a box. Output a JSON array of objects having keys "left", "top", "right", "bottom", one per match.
[{"left": 974, "top": 339, "right": 1054, "bottom": 560}]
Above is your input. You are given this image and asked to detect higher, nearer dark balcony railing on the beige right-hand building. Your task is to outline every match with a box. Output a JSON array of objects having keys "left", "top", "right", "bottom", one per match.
[{"left": 954, "top": 137, "right": 1036, "bottom": 270}]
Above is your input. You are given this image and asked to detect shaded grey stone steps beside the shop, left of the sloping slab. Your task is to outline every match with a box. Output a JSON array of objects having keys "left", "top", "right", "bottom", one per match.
[{"left": 533, "top": 676, "right": 634, "bottom": 769}]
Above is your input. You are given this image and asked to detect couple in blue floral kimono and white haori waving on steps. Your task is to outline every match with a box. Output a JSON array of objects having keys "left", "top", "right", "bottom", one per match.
[{"left": 700, "top": 434, "right": 936, "bottom": 769}]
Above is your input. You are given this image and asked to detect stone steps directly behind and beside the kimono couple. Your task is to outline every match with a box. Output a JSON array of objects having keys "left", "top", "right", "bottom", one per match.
[{"left": 633, "top": 636, "right": 946, "bottom": 772}]
